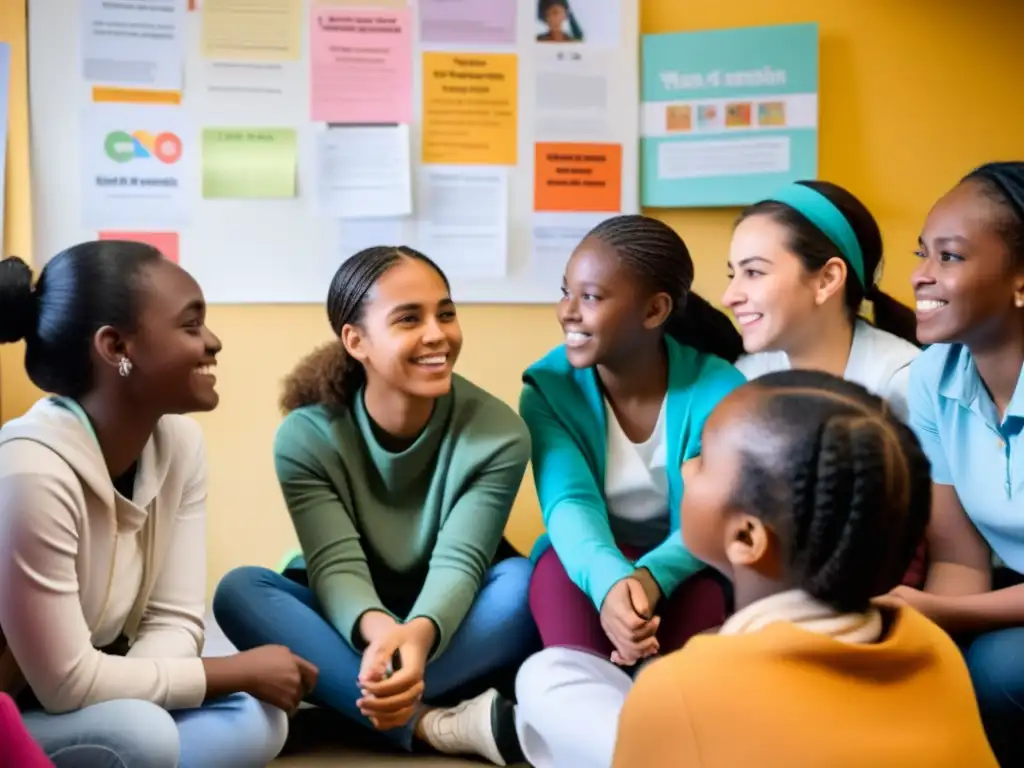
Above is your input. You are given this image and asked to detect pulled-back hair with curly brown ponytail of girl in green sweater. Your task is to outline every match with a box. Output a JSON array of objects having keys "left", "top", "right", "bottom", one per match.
[{"left": 281, "top": 246, "right": 451, "bottom": 414}]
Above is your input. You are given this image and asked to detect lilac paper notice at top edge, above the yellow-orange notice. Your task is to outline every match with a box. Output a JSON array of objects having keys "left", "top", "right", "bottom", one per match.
[{"left": 420, "top": 0, "right": 516, "bottom": 45}]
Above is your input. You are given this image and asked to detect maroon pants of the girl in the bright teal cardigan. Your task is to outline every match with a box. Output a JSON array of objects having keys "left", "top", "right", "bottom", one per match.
[{"left": 529, "top": 547, "right": 726, "bottom": 658}]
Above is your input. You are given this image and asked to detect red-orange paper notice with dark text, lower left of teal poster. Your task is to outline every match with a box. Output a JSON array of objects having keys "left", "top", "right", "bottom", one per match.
[{"left": 534, "top": 142, "right": 623, "bottom": 213}]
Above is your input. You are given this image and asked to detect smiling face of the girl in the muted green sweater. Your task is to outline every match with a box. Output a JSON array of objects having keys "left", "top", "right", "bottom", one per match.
[{"left": 341, "top": 258, "right": 462, "bottom": 398}]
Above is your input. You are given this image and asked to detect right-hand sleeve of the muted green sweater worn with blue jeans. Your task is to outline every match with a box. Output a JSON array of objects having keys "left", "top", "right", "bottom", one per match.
[{"left": 407, "top": 428, "right": 529, "bottom": 658}]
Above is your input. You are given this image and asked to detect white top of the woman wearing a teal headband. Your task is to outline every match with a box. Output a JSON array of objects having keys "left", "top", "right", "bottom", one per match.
[{"left": 736, "top": 319, "right": 921, "bottom": 422}]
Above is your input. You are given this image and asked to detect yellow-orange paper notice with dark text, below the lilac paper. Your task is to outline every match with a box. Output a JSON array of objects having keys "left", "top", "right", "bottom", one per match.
[{"left": 423, "top": 51, "right": 519, "bottom": 165}]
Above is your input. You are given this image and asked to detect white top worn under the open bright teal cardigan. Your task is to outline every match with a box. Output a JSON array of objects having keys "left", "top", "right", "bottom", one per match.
[{"left": 604, "top": 401, "right": 670, "bottom": 547}]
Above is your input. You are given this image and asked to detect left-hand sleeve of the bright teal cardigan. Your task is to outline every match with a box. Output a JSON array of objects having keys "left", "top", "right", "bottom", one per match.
[{"left": 519, "top": 383, "right": 634, "bottom": 610}]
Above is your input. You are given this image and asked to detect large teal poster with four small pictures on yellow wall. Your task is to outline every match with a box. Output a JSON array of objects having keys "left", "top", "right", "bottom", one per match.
[{"left": 640, "top": 24, "right": 818, "bottom": 208}]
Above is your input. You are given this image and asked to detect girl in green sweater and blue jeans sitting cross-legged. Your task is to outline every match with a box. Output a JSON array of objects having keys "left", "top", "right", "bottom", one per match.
[{"left": 213, "top": 247, "right": 537, "bottom": 765}]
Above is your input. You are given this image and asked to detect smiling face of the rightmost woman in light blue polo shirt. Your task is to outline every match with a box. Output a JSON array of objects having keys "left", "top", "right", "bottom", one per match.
[{"left": 911, "top": 180, "right": 1024, "bottom": 345}]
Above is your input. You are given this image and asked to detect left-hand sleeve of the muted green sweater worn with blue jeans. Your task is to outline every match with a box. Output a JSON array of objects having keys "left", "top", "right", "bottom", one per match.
[{"left": 273, "top": 412, "right": 392, "bottom": 650}]
